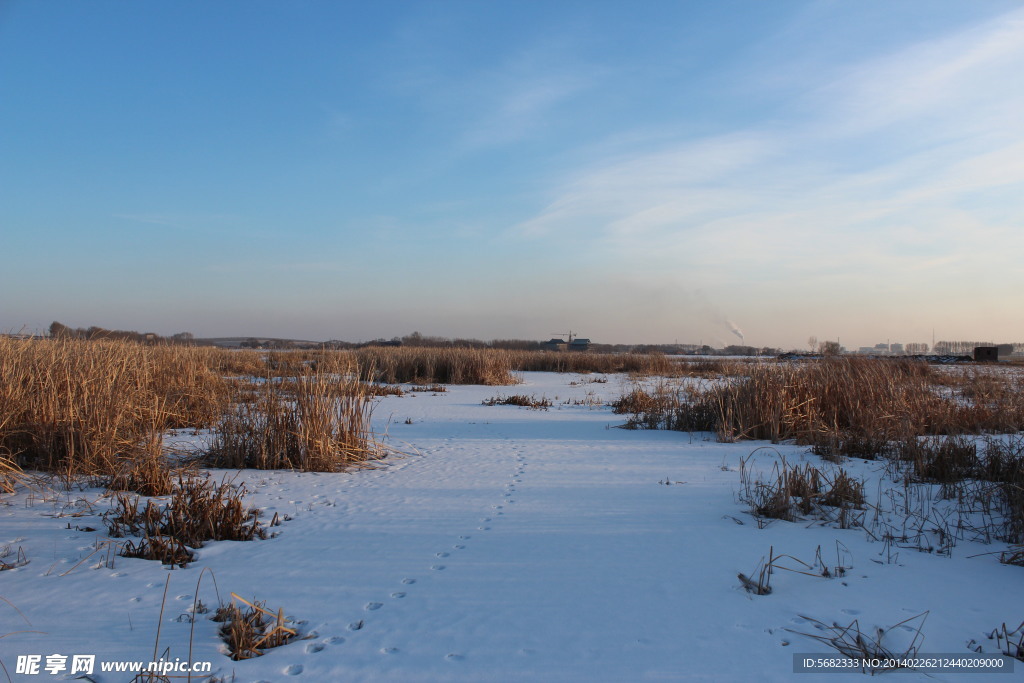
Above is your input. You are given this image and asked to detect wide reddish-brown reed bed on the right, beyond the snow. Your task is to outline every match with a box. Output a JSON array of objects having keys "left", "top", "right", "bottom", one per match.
[{"left": 620, "top": 357, "right": 1024, "bottom": 446}]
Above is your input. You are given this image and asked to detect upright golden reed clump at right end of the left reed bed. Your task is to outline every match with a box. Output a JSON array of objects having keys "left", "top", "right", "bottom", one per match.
[{"left": 207, "top": 369, "right": 385, "bottom": 472}]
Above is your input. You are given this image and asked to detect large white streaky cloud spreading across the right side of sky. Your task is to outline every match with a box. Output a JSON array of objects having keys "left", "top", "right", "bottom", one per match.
[{"left": 515, "top": 3, "right": 1024, "bottom": 284}]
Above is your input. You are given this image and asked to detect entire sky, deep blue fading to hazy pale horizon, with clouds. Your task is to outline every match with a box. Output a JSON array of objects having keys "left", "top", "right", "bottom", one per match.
[{"left": 0, "top": 0, "right": 1024, "bottom": 348}]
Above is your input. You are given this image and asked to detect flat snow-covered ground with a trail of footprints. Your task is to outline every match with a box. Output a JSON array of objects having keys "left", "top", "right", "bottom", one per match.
[{"left": 0, "top": 373, "right": 1024, "bottom": 683}]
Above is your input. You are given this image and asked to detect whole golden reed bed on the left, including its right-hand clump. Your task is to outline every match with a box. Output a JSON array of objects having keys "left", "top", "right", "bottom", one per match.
[{"left": 0, "top": 337, "right": 383, "bottom": 485}]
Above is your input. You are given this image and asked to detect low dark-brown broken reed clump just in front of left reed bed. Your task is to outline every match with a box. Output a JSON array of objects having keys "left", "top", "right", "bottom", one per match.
[{"left": 103, "top": 474, "right": 275, "bottom": 566}]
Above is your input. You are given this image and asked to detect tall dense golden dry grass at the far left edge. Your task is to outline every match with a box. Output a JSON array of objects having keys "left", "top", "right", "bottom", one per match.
[{"left": 0, "top": 338, "right": 225, "bottom": 479}]
